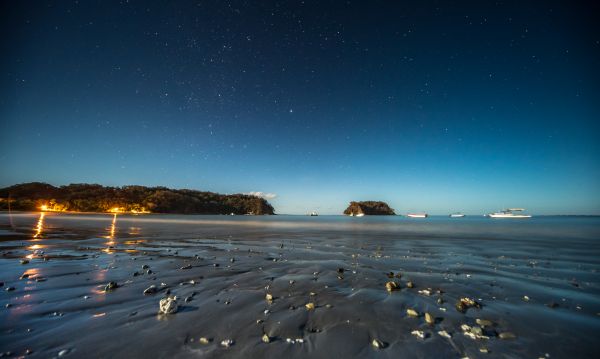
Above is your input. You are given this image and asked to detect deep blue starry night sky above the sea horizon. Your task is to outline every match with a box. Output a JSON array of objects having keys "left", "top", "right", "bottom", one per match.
[{"left": 0, "top": 1, "right": 600, "bottom": 214}]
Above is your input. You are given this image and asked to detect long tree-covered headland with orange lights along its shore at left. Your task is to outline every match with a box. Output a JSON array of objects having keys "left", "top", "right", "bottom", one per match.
[{"left": 0, "top": 182, "right": 275, "bottom": 215}]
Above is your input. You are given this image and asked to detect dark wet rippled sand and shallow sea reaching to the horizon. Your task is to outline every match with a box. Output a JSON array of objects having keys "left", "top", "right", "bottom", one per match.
[{"left": 0, "top": 213, "right": 600, "bottom": 358}]
